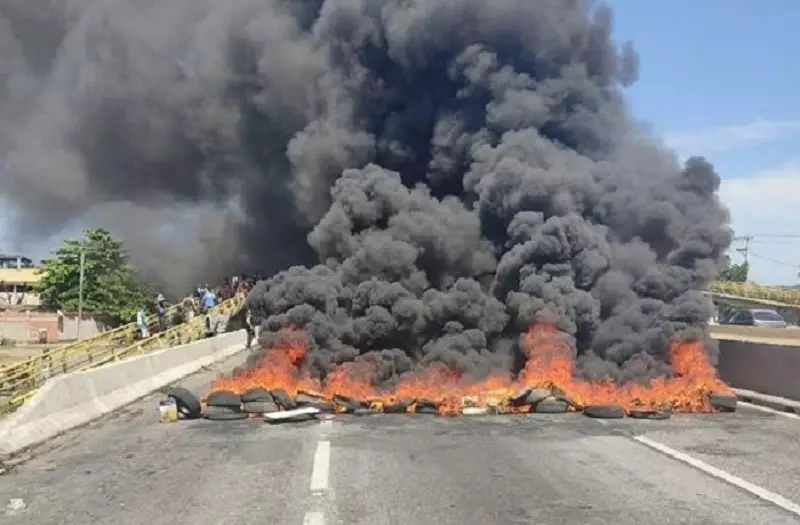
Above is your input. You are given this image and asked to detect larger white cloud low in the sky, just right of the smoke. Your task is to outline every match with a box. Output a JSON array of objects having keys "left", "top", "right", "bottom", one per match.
[{"left": 720, "top": 162, "right": 800, "bottom": 284}]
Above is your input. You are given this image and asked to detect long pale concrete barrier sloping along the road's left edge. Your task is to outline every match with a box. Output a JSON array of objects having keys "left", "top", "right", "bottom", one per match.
[{"left": 0, "top": 330, "right": 247, "bottom": 456}]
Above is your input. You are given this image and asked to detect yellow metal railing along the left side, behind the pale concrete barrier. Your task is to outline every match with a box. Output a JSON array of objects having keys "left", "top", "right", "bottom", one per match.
[{"left": 0, "top": 298, "right": 243, "bottom": 414}]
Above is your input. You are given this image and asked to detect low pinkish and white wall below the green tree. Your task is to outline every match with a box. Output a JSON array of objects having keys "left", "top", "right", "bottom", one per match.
[{"left": 0, "top": 310, "right": 107, "bottom": 343}]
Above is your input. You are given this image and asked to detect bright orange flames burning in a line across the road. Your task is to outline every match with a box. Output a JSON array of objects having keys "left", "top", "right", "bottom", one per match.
[{"left": 213, "top": 324, "right": 732, "bottom": 415}]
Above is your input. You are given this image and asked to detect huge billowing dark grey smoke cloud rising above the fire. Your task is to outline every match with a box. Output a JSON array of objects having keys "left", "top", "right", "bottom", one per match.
[{"left": 0, "top": 0, "right": 731, "bottom": 382}]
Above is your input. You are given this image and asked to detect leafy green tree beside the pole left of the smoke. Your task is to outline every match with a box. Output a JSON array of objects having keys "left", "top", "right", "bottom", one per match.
[{"left": 34, "top": 229, "right": 154, "bottom": 323}]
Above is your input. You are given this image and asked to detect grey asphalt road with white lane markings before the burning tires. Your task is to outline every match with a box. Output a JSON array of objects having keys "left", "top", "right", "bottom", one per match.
[{"left": 0, "top": 350, "right": 800, "bottom": 525}]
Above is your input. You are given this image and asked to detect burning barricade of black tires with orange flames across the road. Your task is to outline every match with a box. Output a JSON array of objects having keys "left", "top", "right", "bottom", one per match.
[{"left": 170, "top": 325, "right": 736, "bottom": 422}]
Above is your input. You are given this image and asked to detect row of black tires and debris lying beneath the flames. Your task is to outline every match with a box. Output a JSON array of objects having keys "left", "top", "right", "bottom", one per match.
[{"left": 167, "top": 387, "right": 737, "bottom": 422}]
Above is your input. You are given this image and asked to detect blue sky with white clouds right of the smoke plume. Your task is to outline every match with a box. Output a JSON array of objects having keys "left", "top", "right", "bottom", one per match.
[{"left": 0, "top": 0, "right": 800, "bottom": 284}]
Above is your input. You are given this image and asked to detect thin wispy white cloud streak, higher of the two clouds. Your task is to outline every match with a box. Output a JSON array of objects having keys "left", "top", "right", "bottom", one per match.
[{"left": 664, "top": 120, "right": 800, "bottom": 157}]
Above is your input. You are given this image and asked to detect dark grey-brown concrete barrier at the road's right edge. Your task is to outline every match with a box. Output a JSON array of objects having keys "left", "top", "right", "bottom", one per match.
[{"left": 717, "top": 339, "right": 800, "bottom": 401}]
